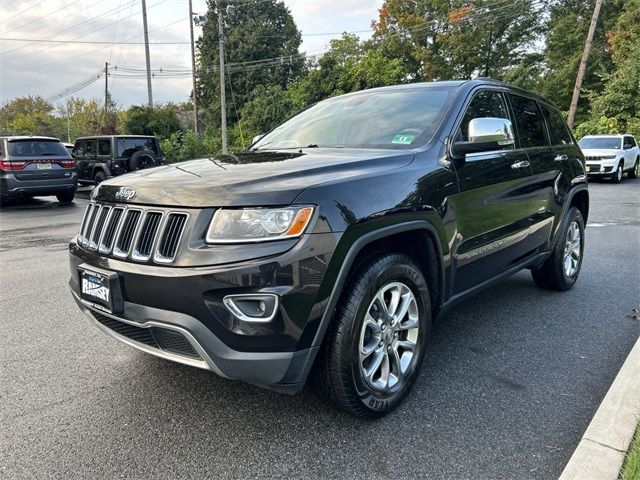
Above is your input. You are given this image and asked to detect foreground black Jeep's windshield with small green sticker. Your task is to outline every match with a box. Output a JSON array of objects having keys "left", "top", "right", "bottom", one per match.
[{"left": 253, "top": 87, "right": 456, "bottom": 150}]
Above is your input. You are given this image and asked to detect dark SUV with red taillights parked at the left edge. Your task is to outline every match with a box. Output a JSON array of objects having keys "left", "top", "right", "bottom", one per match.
[{"left": 0, "top": 136, "right": 78, "bottom": 203}]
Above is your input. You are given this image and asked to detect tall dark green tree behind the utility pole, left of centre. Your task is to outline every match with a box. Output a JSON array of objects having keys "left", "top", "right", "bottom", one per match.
[{"left": 198, "top": 0, "right": 304, "bottom": 126}]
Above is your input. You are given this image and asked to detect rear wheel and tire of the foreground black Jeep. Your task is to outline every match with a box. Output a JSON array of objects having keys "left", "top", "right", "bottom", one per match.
[{"left": 531, "top": 207, "right": 584, "bottom": 292}]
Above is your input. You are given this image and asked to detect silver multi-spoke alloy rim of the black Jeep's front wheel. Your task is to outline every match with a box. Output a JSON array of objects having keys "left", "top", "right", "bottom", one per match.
[{"left": 359, "top": 282, "right": 420, "bottom": 392}]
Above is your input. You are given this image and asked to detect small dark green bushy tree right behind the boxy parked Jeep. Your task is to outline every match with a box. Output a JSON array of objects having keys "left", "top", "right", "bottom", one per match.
[{"left": 124, "top": 104, "right": 182, "bottom": 138}]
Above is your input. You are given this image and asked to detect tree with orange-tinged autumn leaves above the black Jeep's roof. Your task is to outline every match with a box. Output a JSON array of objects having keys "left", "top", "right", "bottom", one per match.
[{"left": 373, "top": 0, "right": 543, "bottom": 81}]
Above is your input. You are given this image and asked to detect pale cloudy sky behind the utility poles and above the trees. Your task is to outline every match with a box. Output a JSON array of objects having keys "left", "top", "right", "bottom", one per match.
[{"left": 0, "top": 0, "right": 383, "bottom": 107}]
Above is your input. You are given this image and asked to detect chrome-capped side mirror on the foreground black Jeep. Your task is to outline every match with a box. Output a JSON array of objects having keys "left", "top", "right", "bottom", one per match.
[{"left": 452, "top": 117, "right": 515, "bottom": 155}]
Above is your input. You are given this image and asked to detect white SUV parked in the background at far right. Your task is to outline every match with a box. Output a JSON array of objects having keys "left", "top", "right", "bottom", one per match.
[{"left": 578, "top": 134, "right": 640, "bottom": 183}]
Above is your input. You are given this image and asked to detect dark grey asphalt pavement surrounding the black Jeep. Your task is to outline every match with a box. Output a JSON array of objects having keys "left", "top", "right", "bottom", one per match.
[{"left": 0, "top": 180, "right": 640, "bottom": 479}]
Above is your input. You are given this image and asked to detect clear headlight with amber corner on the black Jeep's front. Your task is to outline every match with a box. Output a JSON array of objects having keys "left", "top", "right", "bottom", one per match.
[{"left": 206, "top": 207, "right": 313, "bottom": 243}]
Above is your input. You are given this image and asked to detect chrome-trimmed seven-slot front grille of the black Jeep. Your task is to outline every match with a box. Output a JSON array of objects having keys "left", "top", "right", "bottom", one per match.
[{"left": 78, "top": 203, "right": 189, "bottom": 263}]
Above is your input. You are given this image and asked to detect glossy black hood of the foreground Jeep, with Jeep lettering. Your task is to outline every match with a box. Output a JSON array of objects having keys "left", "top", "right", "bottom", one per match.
[{"left": 92, "top": 148, "right": 414, "bottom": 207}]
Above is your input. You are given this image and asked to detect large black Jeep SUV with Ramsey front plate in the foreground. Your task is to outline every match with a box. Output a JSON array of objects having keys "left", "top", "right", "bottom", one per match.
[{"left": 70, "top": 79, "right": 589, "bottom": 417}]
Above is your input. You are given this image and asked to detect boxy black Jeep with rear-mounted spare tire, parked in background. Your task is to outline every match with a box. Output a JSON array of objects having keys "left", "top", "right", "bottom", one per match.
[{"left": 73, "top": 135, "right": 163, "bottom": 185}]
